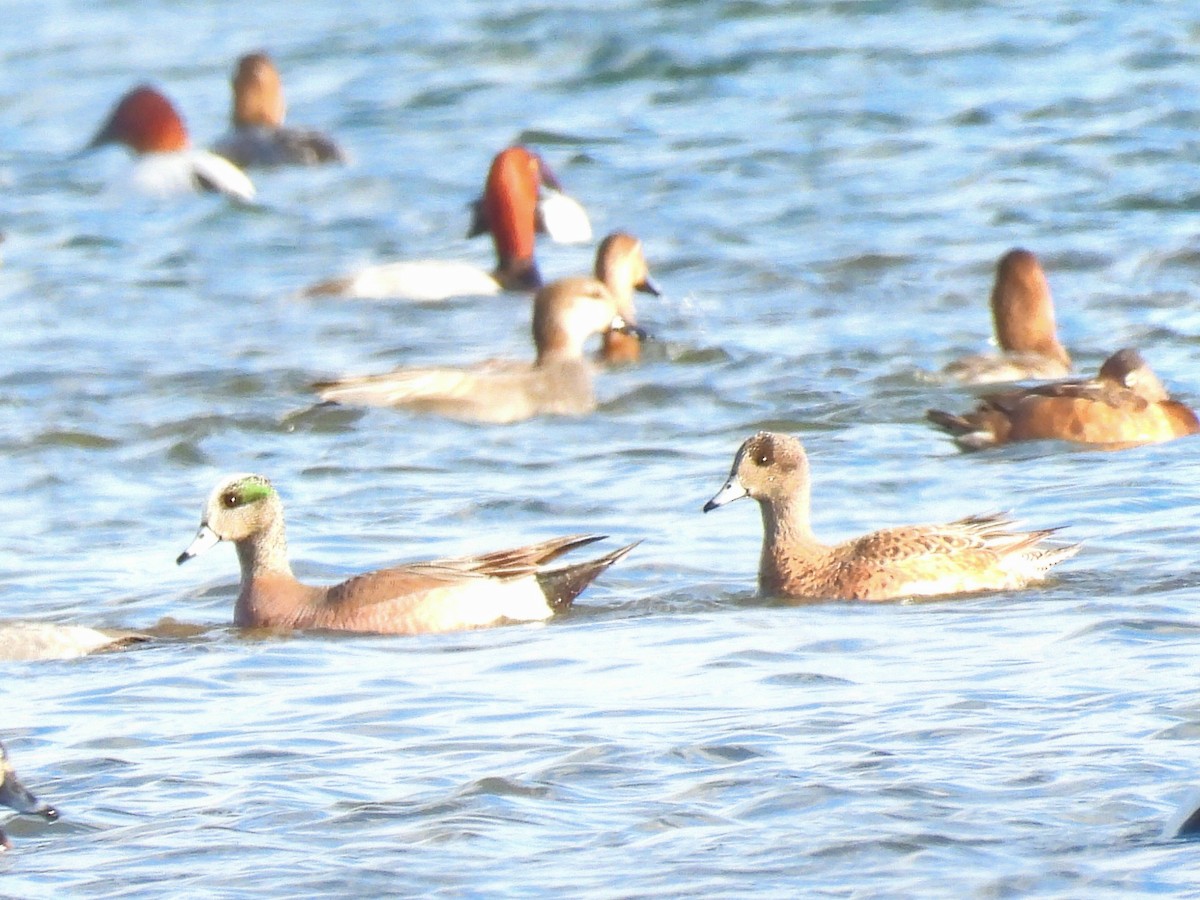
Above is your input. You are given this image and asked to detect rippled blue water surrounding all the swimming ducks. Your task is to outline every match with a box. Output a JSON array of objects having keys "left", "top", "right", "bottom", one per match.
[{"left": 0, "top": 0, "right": 1200, "bottom": 896}]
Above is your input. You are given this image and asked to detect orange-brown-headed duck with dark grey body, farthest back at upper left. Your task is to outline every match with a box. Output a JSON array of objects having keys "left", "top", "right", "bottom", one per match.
[{"left": 212, "top": 50, "right": 347, "bottom": 169}]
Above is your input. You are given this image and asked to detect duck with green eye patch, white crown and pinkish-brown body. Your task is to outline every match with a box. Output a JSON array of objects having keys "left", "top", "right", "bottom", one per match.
[{"left": 175, "top": 474, "right": 636, "bottom": 635}]
